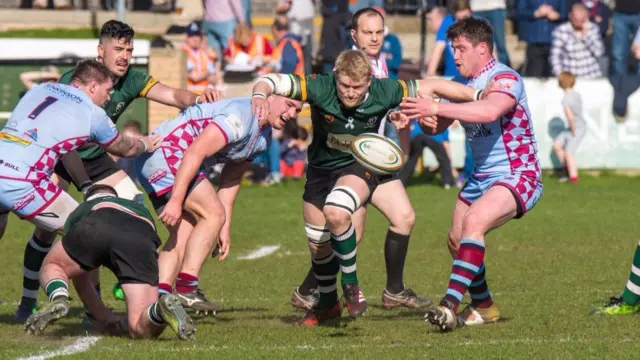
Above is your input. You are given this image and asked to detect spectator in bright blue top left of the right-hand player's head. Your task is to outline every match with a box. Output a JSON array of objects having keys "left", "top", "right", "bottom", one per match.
[{"left": 427, "top": 7, "right": 459, "bottom": 77}]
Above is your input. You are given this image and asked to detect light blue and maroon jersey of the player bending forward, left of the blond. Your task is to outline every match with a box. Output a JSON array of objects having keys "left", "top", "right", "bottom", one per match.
[{"left": 153, "top": 98, "right": 271, "bottom": 163}]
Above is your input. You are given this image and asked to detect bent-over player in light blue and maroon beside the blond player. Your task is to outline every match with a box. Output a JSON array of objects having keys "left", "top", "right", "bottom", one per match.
[{"left": 135, "top": 96, "right": 302, "bottom": 313}]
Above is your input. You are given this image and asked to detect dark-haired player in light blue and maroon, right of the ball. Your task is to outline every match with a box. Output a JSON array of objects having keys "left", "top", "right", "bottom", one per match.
[{"left": 400, "top": 18, "right": 542, "bottom": 331}]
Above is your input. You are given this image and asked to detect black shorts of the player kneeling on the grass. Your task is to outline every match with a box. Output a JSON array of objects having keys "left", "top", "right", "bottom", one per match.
[{"left": 61, "top": 208, "right": 161, "bottom": 286}]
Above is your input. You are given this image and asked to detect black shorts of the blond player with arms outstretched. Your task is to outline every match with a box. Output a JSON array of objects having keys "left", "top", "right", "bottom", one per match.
[{"left": 302, "top": 162, "right": 398, "bottom": 208}]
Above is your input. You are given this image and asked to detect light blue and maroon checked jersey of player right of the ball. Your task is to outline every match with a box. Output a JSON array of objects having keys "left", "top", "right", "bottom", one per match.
[{"left": 454, "top": 59, "right": 541, "bottom": 178}]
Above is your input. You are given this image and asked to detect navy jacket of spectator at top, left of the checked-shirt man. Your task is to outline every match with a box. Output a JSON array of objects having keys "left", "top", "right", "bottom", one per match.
[{"left": 518, "top": 0, "right": 569, "bottom": 45}]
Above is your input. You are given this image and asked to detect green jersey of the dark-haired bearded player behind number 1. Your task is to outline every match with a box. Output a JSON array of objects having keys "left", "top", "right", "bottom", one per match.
[{"left": 60, "top": 68, "right": 158, "bottom": 160}]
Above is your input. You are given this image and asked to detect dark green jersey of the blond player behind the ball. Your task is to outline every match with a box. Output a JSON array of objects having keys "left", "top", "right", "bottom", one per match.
[{"left": 288, "top": 73, "right": 418, "bottom": 169}]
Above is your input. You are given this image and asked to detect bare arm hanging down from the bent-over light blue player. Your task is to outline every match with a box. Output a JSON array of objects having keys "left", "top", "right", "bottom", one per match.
[{"left": 171, "top": 125, "right": 227, "bottom": 204}]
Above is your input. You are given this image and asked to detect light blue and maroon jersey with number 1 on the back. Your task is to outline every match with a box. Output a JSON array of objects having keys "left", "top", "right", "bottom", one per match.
[{"left": 0, "top": 83, "right": 118, "bottom": 181}]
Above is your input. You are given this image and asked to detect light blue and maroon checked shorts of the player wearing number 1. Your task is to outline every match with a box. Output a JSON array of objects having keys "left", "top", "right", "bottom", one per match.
[{"left": 0, "top": 177, "right": 78, "bottom": 232}]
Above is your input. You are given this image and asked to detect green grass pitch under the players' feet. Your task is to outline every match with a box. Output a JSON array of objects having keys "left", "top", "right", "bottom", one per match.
[{"left": 0, "top": 176, "right": 640, "bottom": 360}]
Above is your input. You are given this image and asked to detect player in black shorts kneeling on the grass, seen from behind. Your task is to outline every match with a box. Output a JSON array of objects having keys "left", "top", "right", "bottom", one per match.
[{"left": 25, "top": 184, "right": 195, "bottom": 339}]
